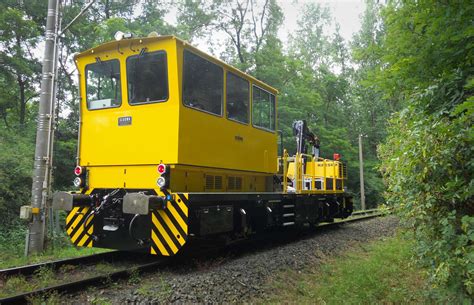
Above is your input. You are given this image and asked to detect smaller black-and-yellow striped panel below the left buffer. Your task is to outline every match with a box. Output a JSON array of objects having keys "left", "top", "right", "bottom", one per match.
[{"left": 66, "top": 207, "right": 94, "bottom": 248}]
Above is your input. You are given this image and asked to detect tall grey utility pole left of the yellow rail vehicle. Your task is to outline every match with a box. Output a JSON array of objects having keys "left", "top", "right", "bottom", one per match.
[{"left": 25, "top": 0, "right": 59, "bottom": 254}]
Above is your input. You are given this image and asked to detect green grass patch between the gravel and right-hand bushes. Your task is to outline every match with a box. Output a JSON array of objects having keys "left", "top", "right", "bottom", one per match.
[{"left": 263, "top": 234, "right": 433, "bottom": 304}]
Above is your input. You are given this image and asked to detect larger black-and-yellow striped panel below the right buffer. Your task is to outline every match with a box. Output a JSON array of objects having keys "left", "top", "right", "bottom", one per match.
[{"left": 150, "top": 191, "right": 189, "bottom": 256}]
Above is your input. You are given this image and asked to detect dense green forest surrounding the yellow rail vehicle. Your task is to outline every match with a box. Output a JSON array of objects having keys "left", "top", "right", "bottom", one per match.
[{"left": 0, "top": 0, "right": 474, "bottom": 297}]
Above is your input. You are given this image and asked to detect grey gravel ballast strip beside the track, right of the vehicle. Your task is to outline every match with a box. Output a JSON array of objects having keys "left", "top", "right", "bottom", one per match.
[{"left": 71, "top": 216, "right": 398, "bottom": 304}]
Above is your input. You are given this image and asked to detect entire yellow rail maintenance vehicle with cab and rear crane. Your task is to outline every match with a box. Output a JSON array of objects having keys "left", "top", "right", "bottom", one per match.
[{"left": 53, "top": 36, "right": 352, "bottom": 256}]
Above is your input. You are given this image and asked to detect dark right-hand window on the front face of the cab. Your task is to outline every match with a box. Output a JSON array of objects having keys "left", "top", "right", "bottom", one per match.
[{"left": 127, "top": 51, "right": 168, "bottom": 105}]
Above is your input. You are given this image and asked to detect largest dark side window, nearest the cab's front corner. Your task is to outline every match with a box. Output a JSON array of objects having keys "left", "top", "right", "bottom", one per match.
[{"left": 183, "top": 50, "right": 224, "bottom": 115}]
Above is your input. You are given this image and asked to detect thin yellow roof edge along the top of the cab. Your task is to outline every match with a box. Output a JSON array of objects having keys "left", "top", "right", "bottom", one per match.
[{"left": 74, "top": 35, "right": 278, "bottom": 93}]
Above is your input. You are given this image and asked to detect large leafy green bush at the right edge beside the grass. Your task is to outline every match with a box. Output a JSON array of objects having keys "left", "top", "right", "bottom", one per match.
[{"left": 380, "top": 75, "right": 474, "bottom": 299}]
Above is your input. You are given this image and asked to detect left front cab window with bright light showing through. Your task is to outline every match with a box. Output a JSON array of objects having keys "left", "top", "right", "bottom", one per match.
[{"left": 86, "top": 59, "right": 122, "bottom": 110}]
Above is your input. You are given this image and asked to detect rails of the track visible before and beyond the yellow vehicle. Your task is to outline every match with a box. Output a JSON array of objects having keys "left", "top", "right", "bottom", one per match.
[{"left": 0, "top": 209, "right": 386, "bottom": 304}]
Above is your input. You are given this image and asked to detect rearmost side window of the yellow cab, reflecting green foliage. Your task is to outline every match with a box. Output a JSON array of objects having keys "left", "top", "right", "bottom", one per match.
[{"left": 252, "top": 86, "right": 275, "bottom": 130}]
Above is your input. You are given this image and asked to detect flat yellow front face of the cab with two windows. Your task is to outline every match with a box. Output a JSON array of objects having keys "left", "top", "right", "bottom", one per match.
[{"left": 75, "top": 39, "right": 179, "bottom": 189}]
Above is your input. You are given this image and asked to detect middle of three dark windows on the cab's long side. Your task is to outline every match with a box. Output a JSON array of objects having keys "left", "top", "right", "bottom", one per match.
[{"left": 226, "top": 72, "right": 250, "bottom": 123}]
